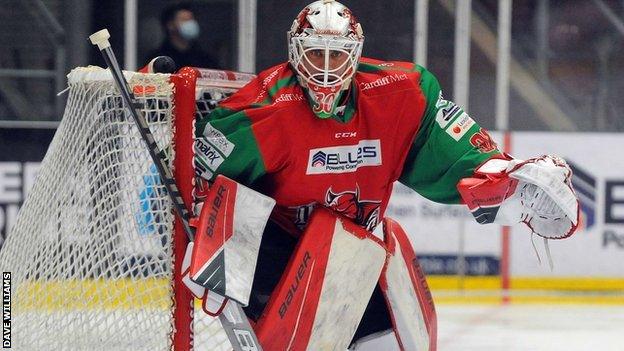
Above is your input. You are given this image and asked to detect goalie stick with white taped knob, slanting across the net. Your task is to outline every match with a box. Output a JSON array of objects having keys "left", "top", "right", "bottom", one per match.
[{"left": 89, "top": 29, "right": 262, "bottom": 351}]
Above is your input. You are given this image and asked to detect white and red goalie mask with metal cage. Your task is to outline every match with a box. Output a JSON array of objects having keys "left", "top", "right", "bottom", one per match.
[{"left": 288, "top": 0, "right": 364, "bottom": 118}]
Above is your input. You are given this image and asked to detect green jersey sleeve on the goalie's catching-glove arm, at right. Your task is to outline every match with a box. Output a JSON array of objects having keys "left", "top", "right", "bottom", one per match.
[{"left": 399, "top": 65, "right": 501, "bottom": 204}]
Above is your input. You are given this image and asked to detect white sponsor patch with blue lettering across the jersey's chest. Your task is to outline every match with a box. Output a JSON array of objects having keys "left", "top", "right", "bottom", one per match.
[{"left": 306, "top": 139, "right": 381, "bottom": 174}]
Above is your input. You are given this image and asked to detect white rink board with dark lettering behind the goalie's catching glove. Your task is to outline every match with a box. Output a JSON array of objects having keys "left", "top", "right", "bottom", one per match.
[{"left": 387, "top": 132, "right": 624, "bottom": 284}]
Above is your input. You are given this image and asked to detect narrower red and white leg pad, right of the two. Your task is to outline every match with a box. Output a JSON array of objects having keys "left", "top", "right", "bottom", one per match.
[{"left": 380, "top": 218, "right": 437, "bottom": 351}]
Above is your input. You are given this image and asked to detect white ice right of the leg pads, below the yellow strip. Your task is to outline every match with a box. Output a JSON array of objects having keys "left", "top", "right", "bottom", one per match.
[{"left": 356, "top": 305, "right": 624, "bottom": 351}]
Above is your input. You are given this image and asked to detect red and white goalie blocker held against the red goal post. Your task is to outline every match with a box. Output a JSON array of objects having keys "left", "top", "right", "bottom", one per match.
[{"left": 183, "top": 175, "right": 275, "bottom": 315}]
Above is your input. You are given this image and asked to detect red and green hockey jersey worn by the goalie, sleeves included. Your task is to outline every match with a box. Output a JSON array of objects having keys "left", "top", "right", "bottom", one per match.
[{"left": 195, "top": 58, "right": 500, "bottom": 233}]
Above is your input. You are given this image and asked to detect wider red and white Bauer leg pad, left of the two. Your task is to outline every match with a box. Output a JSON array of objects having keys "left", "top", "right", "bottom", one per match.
[{"left": 256, "top": 209, "right": 387, "bottom": 350}]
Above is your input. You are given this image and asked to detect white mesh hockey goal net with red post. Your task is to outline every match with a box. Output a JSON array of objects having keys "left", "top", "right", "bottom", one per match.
[{"left": 0, "top": 67, "right": 251, "bottom": 350}]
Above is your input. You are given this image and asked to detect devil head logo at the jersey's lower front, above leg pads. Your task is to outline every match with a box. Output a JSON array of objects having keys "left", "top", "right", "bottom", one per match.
[{"left": 325, "top": 186, "right": 381, "bottom": 231}]
